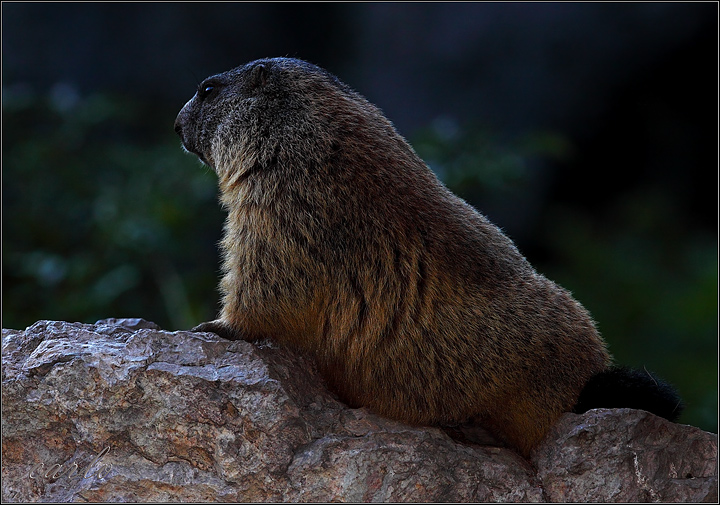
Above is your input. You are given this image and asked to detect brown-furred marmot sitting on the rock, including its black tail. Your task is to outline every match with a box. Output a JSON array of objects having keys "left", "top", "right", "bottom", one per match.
[{"left": 175, "top": 58, "right": 680, "bottom": 456}]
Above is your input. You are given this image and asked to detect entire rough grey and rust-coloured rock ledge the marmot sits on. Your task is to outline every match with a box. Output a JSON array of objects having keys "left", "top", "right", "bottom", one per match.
[{"left": 2, "top": 319, "right": 717, "bottom": 502}]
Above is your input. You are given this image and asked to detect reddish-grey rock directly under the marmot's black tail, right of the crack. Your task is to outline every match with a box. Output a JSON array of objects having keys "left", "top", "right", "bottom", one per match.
[{"left": 531, "top": 409, "right": 718, "bottom": 503}]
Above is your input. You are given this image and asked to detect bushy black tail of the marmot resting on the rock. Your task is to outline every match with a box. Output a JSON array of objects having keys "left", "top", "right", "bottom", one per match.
[{"left": 573, "top": 366, "right": 684, "bottom": 421}]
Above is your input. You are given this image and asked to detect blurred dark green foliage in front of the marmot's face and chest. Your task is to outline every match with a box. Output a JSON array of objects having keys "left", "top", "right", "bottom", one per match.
[{"left": 2, "top": 85, "right": 223, "bottom": 328}]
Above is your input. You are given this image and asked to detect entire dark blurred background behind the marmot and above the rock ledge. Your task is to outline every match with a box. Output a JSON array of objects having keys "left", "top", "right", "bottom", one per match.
[{"left": 2, "top": 2, "right": 718, "bottom": 431}]
